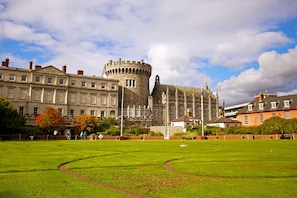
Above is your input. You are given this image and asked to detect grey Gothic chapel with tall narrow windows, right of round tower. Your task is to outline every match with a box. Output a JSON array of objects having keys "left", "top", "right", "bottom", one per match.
[{"left": 149, "top": 75, "right": 219, "bottom": 126}]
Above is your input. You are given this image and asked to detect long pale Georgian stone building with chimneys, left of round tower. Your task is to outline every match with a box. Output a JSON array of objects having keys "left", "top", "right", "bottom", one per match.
[{"left": 0, "top": 58, "right": 119, "bottom": 125}]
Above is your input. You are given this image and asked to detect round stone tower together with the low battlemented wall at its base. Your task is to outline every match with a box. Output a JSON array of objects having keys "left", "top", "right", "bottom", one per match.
[{"left": 104, "top": 59, "right": 152, "bottom": 127}]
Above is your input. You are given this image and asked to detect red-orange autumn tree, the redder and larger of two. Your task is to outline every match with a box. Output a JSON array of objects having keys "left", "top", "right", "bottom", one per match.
[{"left": 35, "top": 107, "right": 66, "bottom": 132}]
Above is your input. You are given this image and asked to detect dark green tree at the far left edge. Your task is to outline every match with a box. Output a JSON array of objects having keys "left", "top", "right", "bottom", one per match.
[{"left": 0, "top": 97, "right": 26, "bottom": 134}]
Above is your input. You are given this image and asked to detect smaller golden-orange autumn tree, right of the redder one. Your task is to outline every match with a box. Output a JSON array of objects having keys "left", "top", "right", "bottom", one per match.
[{"left": 73, "top": 114, "right": 99, "bottom": 132}]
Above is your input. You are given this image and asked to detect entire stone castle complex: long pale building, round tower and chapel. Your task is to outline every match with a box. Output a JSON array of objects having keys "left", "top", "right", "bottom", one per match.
[{"left": 0, "top": 58, "right": 218, "bottom": 127}]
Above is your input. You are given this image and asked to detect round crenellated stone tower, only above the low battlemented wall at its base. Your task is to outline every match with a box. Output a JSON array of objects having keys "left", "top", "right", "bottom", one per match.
[{"left": 104, "top": 59, "right": 152, "bottom": 107}]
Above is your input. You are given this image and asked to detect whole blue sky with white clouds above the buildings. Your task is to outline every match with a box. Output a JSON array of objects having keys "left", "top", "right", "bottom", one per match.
[{"left": 0, "top": 0, "right": 297, "bottom": 106}]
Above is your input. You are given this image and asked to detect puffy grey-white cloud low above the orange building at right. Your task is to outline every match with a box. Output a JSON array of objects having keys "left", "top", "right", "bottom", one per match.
[{"left": 217, "top": 46, "right": 297, "bottom": 104}]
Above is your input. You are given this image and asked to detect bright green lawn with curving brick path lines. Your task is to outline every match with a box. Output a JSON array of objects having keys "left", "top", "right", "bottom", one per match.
[{"left": 0, "top": 140, "right": 297, "bottom": 198}]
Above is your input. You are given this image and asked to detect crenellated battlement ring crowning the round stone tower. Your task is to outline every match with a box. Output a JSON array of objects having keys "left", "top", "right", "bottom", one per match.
[{"left": 104, "top": 59, "right": 152, "bottom": 77}]
